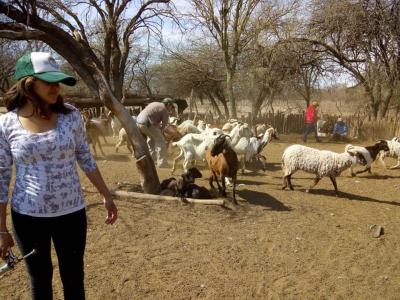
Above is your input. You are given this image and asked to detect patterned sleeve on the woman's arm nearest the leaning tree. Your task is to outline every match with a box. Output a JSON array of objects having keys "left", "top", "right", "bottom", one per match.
[{"left": 72, "top": 110, "right": 97, "bottom": 173}]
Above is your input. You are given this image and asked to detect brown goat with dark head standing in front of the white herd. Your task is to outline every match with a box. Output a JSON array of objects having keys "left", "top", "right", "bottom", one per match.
[{"left": 206, "top": 134, "right": 239, "bottom": 204}]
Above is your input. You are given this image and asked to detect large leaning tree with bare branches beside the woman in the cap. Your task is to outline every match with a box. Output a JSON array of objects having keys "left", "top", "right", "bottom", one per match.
[{"left": 0, "top": 0, "right": 175, "bottom": 193}]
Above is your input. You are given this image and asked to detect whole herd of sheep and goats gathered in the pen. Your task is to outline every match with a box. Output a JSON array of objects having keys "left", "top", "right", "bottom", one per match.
[{"left": 82, "top": 111, "right": 400, "bottom": 204}]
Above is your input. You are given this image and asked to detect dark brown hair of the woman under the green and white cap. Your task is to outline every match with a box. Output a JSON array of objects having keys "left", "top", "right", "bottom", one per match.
[{"left": 3, "top": 76, "right": 72, "bottom": 119}]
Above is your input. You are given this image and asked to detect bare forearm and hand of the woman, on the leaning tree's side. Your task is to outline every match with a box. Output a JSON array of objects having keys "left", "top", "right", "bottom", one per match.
[{"left": 85, "top": 167, "right": 118, "bottom": 224}]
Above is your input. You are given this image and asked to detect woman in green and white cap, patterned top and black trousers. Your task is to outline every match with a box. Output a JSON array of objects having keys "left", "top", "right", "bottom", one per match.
[{"left": 0, "top": 52, "right": 117, "bottom": 300}]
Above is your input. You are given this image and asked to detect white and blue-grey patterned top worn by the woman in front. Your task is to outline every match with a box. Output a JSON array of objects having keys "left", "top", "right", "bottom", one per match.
[{"left": 0, "top": 104, "right": 97, "bottom": 217}]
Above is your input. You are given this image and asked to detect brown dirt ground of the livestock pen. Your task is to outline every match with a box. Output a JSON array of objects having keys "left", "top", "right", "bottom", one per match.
[{"left": 0, "top": 136, "right": 400, "bottom": 299}]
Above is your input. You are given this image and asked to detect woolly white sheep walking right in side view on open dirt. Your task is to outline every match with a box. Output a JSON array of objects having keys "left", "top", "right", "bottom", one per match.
[{"left": 282, "top": 145, "right": 366, "bottom": 195}]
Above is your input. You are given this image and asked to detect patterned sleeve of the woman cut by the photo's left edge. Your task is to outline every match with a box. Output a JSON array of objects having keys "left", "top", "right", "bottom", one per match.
[{"left": 0, "top": 120, "right": 12, "bottom": 203}]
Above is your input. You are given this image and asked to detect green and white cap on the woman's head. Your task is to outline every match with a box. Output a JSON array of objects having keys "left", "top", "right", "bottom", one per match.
[{"left": 15, "top": 52, "right": 76, "bottom": 86}]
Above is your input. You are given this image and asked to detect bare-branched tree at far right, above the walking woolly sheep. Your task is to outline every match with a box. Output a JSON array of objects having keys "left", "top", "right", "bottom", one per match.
[{"left": 304, "top": 0, "right": 400, "bottom": 119}]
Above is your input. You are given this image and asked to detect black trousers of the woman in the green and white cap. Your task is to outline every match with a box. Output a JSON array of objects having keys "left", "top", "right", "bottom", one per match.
[{"left": 11, "top": 209, "right": 87, "bottom": 300}]
